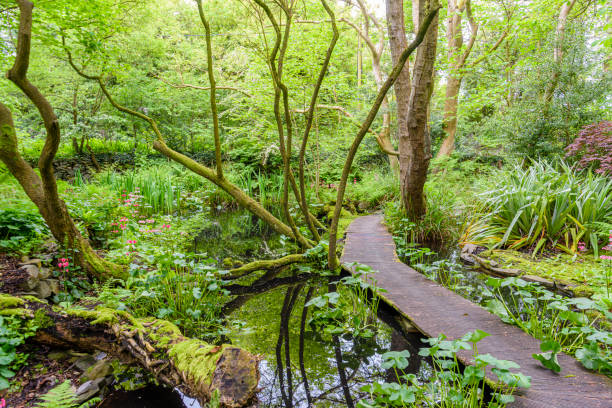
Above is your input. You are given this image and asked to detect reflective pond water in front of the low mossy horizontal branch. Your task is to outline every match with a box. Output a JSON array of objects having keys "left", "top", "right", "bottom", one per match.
[{"left": 102, "top": 270, "right": 429, "bottom": 408}]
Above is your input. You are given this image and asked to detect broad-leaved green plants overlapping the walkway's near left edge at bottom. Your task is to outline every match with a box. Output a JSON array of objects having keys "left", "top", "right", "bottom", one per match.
[{"left": 357, "top": 330, "right": 531, "bottom": 408}]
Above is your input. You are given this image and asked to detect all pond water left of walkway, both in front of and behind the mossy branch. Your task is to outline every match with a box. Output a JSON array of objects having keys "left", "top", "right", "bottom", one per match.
[{"left": 101, "top": 212, "right": 436, "bottom": 408}]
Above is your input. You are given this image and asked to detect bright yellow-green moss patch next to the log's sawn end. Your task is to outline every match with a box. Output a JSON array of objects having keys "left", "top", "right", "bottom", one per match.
[{"left": 168, "top": 339, "right": 227, "bottom": 385}]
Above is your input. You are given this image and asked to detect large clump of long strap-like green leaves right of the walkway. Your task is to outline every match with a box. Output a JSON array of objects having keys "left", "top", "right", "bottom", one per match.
[{"left": 462, "top": 161, "right": 612, "bottom": 256}]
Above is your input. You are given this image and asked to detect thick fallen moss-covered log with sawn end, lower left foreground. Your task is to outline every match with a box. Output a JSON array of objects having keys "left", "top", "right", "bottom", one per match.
[{"left": 0, "top": 294, "right": 259, "bottom": 407}]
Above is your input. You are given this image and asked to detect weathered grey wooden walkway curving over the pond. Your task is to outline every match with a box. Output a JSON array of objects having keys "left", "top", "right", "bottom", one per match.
[{"left": 342, "top": 215, "right": 612, "bottom": 408}]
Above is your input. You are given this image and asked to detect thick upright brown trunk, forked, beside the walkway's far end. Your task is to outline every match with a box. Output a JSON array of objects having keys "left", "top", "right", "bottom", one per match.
[{"left": 386, "top": 0, "right": 438, "bottom": 219}]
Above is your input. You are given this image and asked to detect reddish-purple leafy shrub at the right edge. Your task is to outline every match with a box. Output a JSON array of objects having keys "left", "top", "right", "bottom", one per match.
[{"left": 565, "top": 120, "right": 612, "bottom": 177}]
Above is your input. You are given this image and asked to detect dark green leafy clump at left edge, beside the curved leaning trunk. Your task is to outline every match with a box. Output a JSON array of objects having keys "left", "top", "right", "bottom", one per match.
[{"left": 0, "top": 208, "right": 48, "bottom": 253}]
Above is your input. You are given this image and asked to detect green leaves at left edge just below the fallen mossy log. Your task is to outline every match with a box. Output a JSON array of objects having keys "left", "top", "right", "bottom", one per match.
[{"left": 0, "top": 316, "right": 38, "bottom": 390}]
